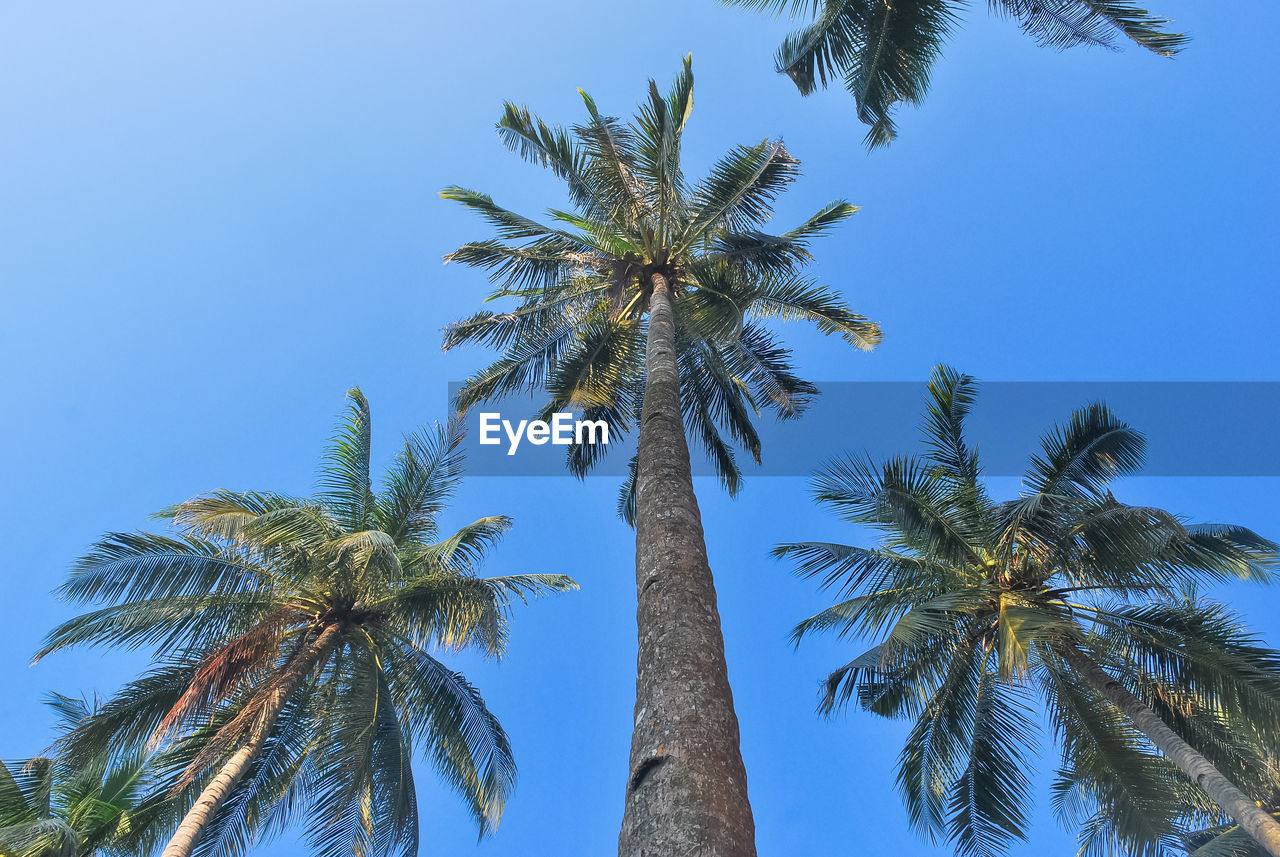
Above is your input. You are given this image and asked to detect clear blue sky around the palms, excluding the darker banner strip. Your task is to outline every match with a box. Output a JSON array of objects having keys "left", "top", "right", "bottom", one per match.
[{"left": 0, "top": 0, "right": 1280, "bottom": 857}]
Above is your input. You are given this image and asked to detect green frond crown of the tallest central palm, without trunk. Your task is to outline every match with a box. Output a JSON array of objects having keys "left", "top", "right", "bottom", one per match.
[{"left": 442, "top": 58, "right": 879, "bottom": 514}]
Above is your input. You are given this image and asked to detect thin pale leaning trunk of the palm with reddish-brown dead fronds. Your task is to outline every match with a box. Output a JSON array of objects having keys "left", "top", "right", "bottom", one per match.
[{"left": 160, "top": 624, "right": 340, "bottom": 857}]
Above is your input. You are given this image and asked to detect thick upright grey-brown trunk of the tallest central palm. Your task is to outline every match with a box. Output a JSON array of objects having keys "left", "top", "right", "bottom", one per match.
[{"left": 618, "top": 274, "right": 755, "bottom": 857}]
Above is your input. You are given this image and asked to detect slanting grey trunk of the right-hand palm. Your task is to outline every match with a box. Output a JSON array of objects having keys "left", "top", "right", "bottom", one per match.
[{"left": 1053, "top": 643, "right": 1280, "bottom": 857}]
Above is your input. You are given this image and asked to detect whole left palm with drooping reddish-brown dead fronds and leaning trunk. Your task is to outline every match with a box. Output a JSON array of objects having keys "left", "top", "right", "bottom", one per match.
[{"left": 37, "top": 390, "right": 575, "bottom": 857}]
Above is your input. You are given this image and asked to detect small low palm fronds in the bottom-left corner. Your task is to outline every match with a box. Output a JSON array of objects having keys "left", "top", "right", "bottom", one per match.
[{"left": 0, "top": 693, "right": 150, "bottom": 857}]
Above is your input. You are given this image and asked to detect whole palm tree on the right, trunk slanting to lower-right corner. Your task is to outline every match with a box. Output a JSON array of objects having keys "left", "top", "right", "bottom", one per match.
[{"left": 776, "top": 367, "right": 1280, "bottom": 856}]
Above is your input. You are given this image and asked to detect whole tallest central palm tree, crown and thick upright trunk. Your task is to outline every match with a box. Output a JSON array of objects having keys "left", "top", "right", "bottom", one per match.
[{"left": 442, "top": 59, "right": 879, "bottom": 857}]
